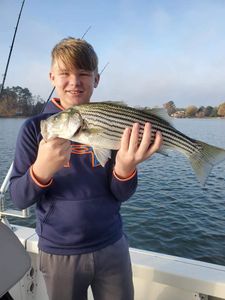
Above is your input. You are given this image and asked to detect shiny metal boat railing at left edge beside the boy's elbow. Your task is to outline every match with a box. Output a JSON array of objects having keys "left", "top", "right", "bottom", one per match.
[{"left": 0, "top": 162, "right": 30, "bottom": 223}]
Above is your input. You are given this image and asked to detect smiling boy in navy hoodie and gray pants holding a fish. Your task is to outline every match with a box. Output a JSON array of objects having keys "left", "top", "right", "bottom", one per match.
[{"left": 10, "top": 38, "right": 162, "bottom": 300}]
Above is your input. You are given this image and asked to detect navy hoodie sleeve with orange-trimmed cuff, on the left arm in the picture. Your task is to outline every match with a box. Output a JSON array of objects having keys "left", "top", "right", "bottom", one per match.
[{"left": 9, "top": 119, "right": 51, "bottom": 209}]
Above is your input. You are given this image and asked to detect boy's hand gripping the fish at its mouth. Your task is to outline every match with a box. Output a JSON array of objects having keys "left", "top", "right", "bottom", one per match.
[{"left": 33, "top": 137, "right": 71, "bottom": 184}]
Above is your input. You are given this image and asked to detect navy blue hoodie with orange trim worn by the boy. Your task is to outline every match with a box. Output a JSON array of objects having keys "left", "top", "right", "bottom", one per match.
[{"left": 10, "top": 99, "right": 137, "bottom": 255}]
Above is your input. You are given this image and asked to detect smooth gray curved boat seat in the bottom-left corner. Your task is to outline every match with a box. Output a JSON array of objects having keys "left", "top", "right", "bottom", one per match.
[{"left": 0, "top": 221, "right": 31, "bottom": 297}]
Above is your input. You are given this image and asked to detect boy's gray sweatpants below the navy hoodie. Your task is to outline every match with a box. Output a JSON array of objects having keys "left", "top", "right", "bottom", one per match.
[{"left": 40, "top": 236, "right": 134, "bottom": 300}]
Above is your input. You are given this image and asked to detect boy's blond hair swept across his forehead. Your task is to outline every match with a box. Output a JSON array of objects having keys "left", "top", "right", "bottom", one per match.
[{"left": 51, "top": 37, "right": 98, "bottom": 72}]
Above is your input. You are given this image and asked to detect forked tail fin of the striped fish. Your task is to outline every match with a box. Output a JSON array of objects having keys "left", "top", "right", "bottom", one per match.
[{"left": 189, "top": 140, "right": 225, "bottom": 185}]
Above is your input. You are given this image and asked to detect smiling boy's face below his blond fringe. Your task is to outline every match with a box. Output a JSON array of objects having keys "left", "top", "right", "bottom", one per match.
[{"left": 49, "top": 62, "right": 99, "bottom": 109}]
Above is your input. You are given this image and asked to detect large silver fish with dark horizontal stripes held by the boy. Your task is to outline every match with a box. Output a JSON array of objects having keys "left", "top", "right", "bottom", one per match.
[{"left": 40, "top": 102, "right": 225, "bottom": 185}]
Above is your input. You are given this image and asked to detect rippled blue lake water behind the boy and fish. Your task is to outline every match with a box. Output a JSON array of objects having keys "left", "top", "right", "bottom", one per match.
[{"left": 0, "top": 119, "right": 225, "bottom": 265}]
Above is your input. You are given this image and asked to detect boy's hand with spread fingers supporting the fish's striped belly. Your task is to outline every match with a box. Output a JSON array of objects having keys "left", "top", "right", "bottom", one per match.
[{"left": 114, "top": 123, "right": 162, "bottom": 178}]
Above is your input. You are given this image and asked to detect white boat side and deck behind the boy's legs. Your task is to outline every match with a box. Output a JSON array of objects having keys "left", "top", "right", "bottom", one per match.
[{"left": 7, "top": 227, "right": 225, "bottom": 300}]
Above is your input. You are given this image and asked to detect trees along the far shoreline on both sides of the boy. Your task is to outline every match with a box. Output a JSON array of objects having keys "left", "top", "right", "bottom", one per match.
[{"left": 0, "top": 86, "right": 225, "bottom": 118}]
